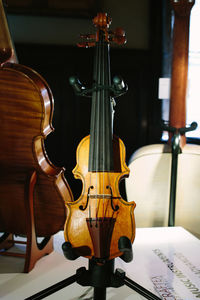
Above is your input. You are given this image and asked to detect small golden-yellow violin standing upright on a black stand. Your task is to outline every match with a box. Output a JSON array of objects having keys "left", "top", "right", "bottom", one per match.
[{"left": 63, "top": 13, "right": 136, "bottom": 262}]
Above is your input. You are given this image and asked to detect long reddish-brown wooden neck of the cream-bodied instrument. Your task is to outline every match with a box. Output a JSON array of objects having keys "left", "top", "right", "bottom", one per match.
[{"left": 169, "top": 0, "right": 194, "bottom": 146}]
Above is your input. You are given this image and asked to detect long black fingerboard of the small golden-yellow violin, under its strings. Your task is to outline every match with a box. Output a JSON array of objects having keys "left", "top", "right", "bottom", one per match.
[{"left": 89, "top": 31, "right": 114, "bottom": 172}]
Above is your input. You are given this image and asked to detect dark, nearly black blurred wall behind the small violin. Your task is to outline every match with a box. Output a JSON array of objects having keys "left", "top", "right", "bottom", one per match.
[{"left": 6, "top": 0, "right": 162, "bottom": 198}]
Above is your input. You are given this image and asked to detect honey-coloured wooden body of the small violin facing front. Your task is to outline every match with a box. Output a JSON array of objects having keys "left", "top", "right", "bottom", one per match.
[{"left": 64, "top": 136, "right": 135, "bottom": 259}]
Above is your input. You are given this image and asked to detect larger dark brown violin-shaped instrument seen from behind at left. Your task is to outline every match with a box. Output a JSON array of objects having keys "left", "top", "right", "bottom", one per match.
[{"left": 0, "top": 2, "right": 73, "bottom": 272}]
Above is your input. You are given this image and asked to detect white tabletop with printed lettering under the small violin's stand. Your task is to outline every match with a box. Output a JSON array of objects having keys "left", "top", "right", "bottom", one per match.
[{"left": 0, "top": 227, "right": 200, "bottom": 300}]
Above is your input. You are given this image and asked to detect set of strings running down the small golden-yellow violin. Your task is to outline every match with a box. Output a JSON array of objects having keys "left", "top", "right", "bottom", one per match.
[{"left": 94, "top": 29, "right": 112, "bottom": 223}]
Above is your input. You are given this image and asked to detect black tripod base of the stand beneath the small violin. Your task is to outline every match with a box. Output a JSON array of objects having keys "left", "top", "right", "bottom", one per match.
[{"left": 25, "top": 259, "right": 160, "bottom": 300}]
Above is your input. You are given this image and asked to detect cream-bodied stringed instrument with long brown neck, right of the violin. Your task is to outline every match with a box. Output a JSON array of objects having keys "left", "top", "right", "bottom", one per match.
[{"left": 126, "top": 0, "right": 200, "bottom": 236}]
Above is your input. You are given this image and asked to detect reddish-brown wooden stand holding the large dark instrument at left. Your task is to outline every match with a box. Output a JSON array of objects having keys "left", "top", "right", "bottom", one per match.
[{"left": 0, "top": 171, "right": 53, "bottom": 273}]
